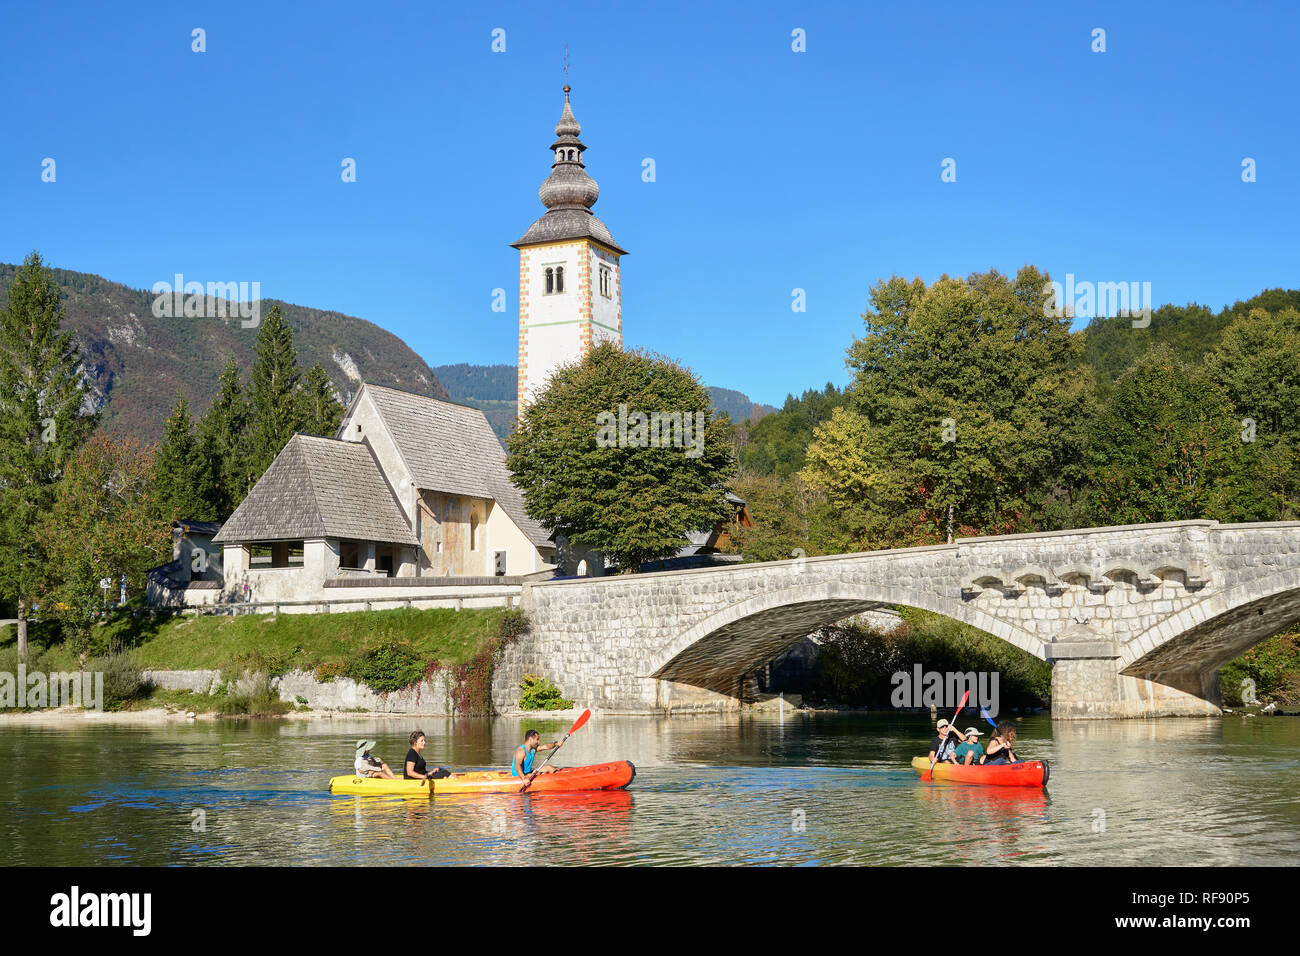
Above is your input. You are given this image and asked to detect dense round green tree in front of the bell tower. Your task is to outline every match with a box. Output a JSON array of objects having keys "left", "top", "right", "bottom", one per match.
[{"left": 507, "top": 343, "right": 735, "bottom": 572}]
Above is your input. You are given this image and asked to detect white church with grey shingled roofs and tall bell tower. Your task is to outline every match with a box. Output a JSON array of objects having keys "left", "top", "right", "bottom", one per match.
[{"left": 150, "top": 86, "right": 744, "bottom": 610}]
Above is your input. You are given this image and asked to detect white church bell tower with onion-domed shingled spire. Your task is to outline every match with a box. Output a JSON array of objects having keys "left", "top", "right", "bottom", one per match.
[{"left": 511, "top": 86, "right": 627, "bottom": 414}]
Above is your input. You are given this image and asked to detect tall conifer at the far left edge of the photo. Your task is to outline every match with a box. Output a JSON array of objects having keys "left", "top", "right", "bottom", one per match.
[{"left": 0, "top": 252, "right": 96, "bottom": 657}]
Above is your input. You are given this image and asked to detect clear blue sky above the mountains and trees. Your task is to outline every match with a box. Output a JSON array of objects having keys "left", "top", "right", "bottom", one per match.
[{"left": 0, "top": 0, "right": 1300, "bottom": 403}]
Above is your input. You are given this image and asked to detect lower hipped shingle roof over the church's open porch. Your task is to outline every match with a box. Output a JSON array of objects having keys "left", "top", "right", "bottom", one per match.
[{"left": 213, "top": 434, "right": 419, "bottom": 545}]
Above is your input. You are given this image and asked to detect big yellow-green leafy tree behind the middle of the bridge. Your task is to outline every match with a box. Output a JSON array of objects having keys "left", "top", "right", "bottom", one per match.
[{"left": 802, "top": 265, "right": 1092, "bottom": 548}]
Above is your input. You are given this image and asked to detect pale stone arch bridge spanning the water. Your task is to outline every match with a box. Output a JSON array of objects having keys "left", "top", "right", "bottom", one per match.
[{"left": 494, "top": 520, "right": 1300, "bottom": 718}]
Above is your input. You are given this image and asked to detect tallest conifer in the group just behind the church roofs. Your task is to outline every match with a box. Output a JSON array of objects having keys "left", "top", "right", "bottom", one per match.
[{"left": 248, "top": 306, "right": 303, "bottom": 480}]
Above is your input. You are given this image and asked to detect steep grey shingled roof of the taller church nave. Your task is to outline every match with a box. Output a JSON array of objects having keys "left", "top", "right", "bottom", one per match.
[{"left": 356, "top": 384, "right": 551, "bottom": 548}]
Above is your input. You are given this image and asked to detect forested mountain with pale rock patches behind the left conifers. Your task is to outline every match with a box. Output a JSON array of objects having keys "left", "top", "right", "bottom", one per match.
[{"left": 0, "top": 263, "right": 447, "bottom": 442}]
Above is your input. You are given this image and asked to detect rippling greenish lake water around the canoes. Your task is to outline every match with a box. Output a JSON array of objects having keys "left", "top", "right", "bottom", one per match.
[{"left": 0, "top": 713, "right": 1300, "bottom": 866}]
